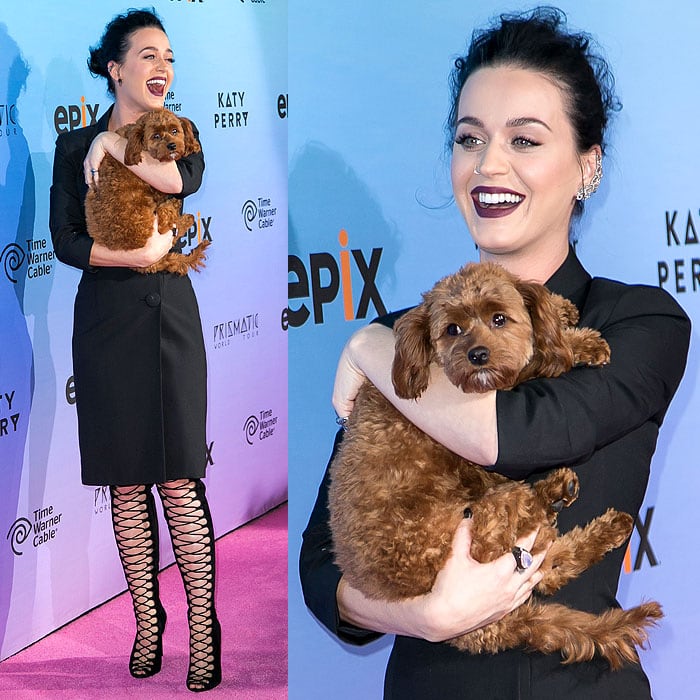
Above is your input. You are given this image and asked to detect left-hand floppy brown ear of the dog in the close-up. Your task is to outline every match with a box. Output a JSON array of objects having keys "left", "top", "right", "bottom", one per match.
[{"left": 391, "top": 302, "right": 433, "bottom": 399}]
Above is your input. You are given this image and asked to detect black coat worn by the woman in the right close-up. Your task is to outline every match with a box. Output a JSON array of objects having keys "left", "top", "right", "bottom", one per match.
[{"left": 300, "top": 251, "right": 690, "bottom": 700}]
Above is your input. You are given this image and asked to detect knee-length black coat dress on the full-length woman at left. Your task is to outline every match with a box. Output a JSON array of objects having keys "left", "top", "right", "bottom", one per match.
[{"left": 49, "top": 109, "right": 206, "bottom": 485}]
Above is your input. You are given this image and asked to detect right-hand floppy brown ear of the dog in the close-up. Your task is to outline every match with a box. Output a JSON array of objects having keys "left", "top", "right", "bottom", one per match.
[{"left": 516, "top": 281, "right": 577, "bottom": 382}]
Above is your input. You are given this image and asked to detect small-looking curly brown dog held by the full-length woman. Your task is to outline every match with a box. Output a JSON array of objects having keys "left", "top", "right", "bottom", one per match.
[{"left": 85, "top": 109, "right": 209, "bottom": 275}]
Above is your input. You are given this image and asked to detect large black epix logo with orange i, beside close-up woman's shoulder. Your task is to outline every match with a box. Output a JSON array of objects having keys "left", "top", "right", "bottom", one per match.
[{"left": 286, "top": 229, "right": 386, "bottom": 328}]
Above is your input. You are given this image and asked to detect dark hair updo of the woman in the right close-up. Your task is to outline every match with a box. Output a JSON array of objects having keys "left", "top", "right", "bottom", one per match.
[{"left": 446, "top": 7, "right": 620, "bottom": 158}]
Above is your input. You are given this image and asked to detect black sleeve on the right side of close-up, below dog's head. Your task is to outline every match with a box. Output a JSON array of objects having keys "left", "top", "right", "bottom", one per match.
[{"left": 495, "top": 281, "right": 690, "bottom": 479}]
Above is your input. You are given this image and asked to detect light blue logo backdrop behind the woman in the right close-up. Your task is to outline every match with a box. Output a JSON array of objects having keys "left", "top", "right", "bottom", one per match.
[{"left": 288, "top": 0, "right": 700, "bottom": 700}]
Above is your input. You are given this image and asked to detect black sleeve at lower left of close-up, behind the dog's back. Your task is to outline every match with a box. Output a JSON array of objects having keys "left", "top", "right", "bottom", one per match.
[{"left": 299, "top": 430, "right": 381, "bottom": 644}]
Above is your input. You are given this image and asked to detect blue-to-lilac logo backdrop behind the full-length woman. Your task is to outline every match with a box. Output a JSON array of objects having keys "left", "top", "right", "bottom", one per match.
[{"left": 0, "top": 0, "right": 288, "bottom": 659}]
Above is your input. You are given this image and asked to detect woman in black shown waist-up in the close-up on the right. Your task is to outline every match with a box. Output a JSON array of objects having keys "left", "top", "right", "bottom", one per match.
[{"left": 300, "top": 9, "right": 690, "bottom": 700}]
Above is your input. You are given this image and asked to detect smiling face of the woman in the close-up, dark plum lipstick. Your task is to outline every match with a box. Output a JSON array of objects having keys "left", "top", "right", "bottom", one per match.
[{"left": 452, "top": 66, "right": 600, "bottom": 258}]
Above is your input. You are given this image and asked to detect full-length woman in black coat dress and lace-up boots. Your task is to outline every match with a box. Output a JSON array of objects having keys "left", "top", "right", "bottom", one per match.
[{"left": 50, "top": 10, "right": 221, "bottom": 692}]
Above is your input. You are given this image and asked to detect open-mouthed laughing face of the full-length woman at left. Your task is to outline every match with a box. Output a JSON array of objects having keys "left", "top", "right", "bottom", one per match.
[{"left": 109, "top": 27, "right": 174, "bottom": 113}]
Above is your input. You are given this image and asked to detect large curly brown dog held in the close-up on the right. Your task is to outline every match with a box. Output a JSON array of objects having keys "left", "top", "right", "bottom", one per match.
[{"left": 329, "top": 263, "right": 662, "bottom": 669}]
